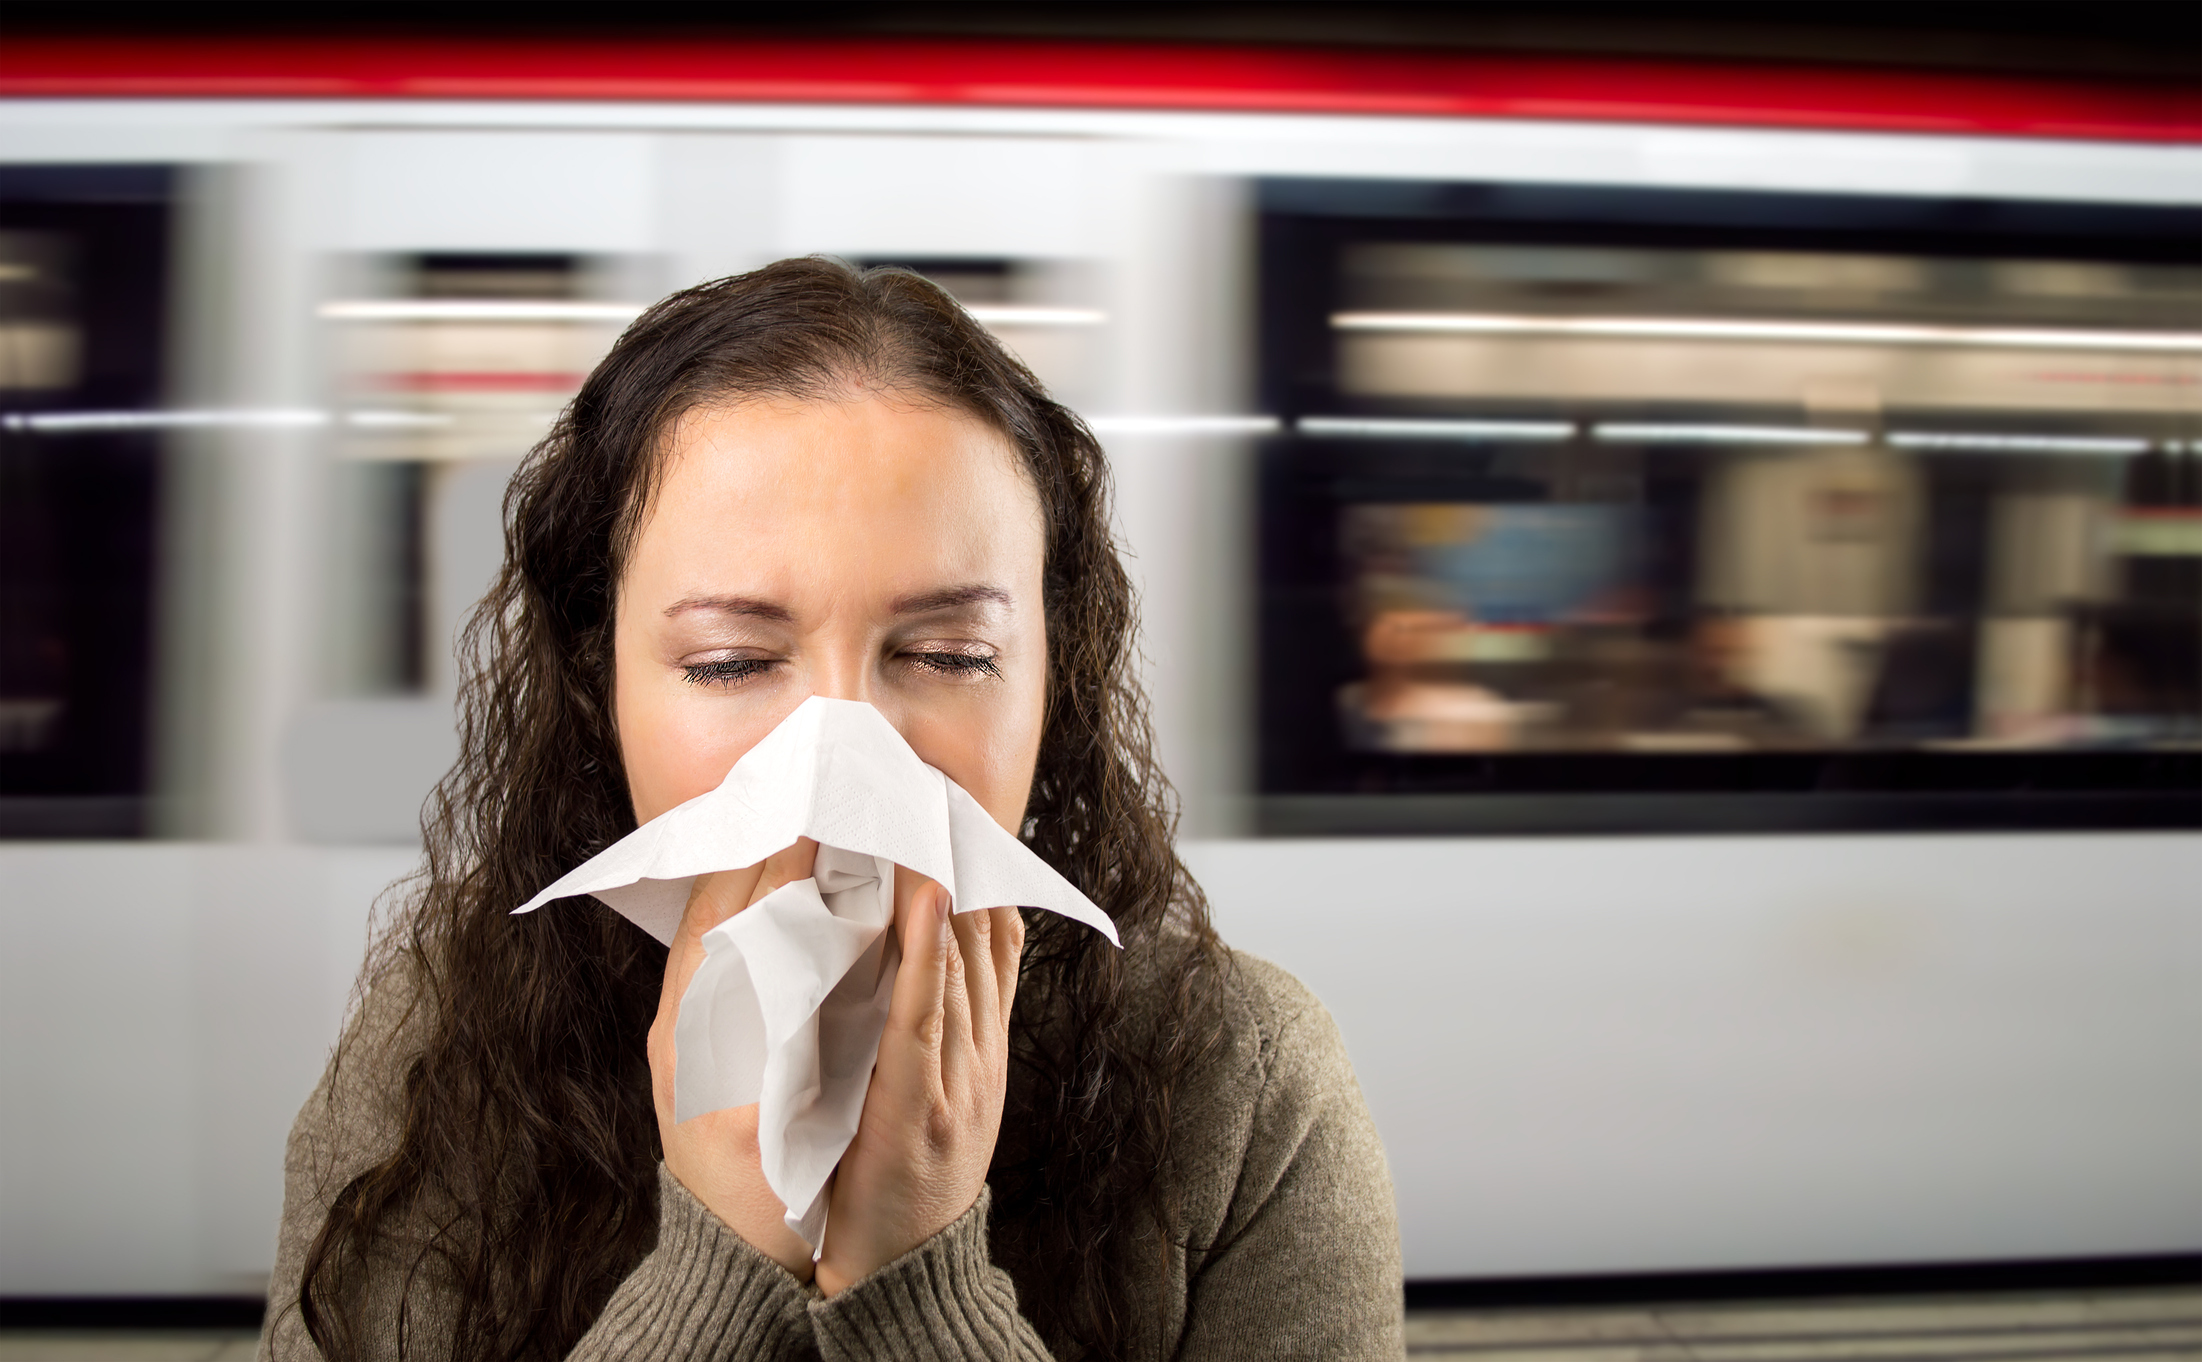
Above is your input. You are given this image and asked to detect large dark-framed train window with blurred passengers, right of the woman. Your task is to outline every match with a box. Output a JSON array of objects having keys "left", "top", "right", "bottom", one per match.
[{"left": 1260, "top": 180, "right": 2202, "bottom": 832}]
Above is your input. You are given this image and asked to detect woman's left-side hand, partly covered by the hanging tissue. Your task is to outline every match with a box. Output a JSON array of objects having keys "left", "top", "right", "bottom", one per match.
[{"left": 650, "top": 838, "right": 827, "bottom": 1281}]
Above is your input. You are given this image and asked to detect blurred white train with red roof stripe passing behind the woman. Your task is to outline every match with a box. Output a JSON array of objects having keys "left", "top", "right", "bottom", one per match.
[{"left": 0, "top": 40, "right": 2202, "bottom": 1296}]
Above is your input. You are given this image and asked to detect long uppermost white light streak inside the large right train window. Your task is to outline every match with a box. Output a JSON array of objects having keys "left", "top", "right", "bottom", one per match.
[{"left": 1330, "top": 312, "right": 2202, "bottom": 354}]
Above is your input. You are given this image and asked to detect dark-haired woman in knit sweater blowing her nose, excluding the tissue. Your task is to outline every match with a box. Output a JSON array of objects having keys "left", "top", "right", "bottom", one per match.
[{"left": 262, "top": 260, "right": 1400, "bottom": 1360}]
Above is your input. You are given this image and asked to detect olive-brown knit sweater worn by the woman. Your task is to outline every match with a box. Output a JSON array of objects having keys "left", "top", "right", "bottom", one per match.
[{"left": 260, "top": 955, "right": 1405, "bottom": 1362}]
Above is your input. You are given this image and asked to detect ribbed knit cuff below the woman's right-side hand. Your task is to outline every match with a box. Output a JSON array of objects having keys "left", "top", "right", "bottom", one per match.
[{"left": 810, "top": 1190, "right": 1048, "bottom": 1362}]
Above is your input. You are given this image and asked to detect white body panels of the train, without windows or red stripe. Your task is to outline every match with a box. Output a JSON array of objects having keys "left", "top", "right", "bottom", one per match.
[{"left": 0, "top": 99, "right": 2202, "bottom": 1296}]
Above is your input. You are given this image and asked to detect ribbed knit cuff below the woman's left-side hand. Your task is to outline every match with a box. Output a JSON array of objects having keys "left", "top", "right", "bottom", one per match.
[{"left": 568, "top": 1164, "right": 817, "bottom": 1362}]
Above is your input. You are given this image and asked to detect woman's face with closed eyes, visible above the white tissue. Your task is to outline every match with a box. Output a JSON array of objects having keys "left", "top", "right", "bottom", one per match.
[{"left": 612, "top": 396, "right": 1048, "bottom": 832}]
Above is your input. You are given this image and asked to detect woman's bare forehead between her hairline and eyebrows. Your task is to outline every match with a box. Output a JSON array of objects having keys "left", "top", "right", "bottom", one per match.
[{"left": 628, "top": 396, "right": 1044, "bottom": 590}]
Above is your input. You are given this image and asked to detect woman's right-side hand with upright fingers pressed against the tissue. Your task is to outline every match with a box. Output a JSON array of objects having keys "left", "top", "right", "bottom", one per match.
[{"left": 817, "top": 867, "right": 1024, "bottom": 1296}]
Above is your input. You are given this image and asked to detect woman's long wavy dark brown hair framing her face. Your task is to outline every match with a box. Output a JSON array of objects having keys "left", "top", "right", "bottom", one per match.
[{"left": 297, "top": 260, "right": 1224, "bottom": 1360}]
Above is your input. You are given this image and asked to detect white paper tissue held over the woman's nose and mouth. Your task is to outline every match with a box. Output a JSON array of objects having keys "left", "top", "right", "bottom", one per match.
[{"left": 513, "top": 695, "right": 1116, "bottom": 1250}]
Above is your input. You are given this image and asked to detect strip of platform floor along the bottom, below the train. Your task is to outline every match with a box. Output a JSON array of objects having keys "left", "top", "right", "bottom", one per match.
[{"left": 0, "top": 1285, "right": 2202, "bottom": 1362}]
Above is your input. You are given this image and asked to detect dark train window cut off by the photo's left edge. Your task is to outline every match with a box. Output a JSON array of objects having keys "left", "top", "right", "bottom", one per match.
[{"left": 0, "top": 165, "right": 170, "bottom": 838}]
